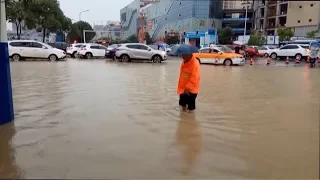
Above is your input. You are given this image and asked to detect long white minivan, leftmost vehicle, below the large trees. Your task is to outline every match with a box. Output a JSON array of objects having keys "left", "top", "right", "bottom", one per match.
[{"left": 8, "top": 40, "right": 66, "bottom": 61}]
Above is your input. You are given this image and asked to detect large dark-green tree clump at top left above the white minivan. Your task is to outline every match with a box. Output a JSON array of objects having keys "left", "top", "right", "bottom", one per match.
[{"left": 6, "top": 0, "right": 71, "bottom": 41}]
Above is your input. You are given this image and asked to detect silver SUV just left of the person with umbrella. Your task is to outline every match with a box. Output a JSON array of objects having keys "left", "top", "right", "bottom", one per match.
[{"left": 115, "top": 43, "right": 168, "bottom": 63}]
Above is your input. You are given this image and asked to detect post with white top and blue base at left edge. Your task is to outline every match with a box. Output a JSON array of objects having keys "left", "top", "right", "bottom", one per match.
[{"left": 0, "top": 0, "right": 14, "bottom": 125}]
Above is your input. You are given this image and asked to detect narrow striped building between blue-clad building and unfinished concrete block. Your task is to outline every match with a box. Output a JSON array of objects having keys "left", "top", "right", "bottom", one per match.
[{"left": 222, "top": 0, "right": 254, "bottom": 40}]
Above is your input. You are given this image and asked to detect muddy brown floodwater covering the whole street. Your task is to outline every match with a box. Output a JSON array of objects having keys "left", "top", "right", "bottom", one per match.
[{"left": 0, "top": 59, "right": 320, "bottom": 179}]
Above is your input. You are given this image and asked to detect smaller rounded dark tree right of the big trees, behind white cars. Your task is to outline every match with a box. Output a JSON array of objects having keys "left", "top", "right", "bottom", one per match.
[{"left": 67, "top": 21, "right": 96, "bottom": 42}]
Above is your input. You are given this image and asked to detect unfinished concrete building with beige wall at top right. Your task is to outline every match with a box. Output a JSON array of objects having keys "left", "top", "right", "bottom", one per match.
[{"left": 254, "top": 0, "right": 320, "bottom": 37}]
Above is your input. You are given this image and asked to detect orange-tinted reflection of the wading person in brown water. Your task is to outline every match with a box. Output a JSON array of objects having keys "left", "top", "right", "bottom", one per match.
[{"left": 176, "top": 112, "right": 202, "bottom": 175}]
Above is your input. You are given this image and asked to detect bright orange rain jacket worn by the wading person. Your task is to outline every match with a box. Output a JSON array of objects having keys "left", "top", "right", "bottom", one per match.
[{"left": 177, "top": 56, "right": 200, "bottom": 94}]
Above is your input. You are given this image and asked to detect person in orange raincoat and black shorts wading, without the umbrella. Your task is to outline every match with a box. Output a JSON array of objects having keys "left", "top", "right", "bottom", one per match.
[{"left": 177, "top": 54, "right": 200, "bottom": 111}]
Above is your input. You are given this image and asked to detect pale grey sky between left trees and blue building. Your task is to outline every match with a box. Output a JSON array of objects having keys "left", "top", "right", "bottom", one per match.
[{"left": 59, "top": 0, "right": 133, "bottom": 25}]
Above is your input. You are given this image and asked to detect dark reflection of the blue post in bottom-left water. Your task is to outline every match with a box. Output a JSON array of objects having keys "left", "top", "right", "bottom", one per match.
[{"left": 0, "top": 123, "right": 22, "bottom": 179}]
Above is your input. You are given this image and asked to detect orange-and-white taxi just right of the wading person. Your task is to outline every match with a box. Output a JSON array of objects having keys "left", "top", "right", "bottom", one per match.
[{"left": 193, "top": 46, "right": 245, "bottom": 66}]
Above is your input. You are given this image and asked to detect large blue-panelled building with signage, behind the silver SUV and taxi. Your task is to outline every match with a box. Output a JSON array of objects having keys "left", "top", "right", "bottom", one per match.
[{"left": 121, "top": 0, "right": 222, "bottom": 40}]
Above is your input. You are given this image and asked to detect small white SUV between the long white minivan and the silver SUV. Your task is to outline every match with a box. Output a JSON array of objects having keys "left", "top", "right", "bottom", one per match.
[{"left": 78, "top": 43, "right": 107, "bottom": 59}]
